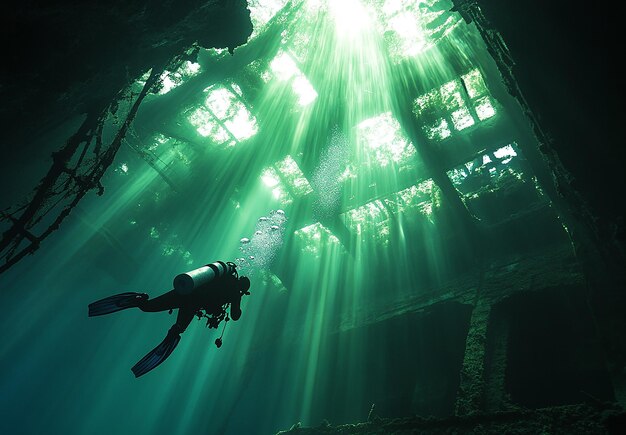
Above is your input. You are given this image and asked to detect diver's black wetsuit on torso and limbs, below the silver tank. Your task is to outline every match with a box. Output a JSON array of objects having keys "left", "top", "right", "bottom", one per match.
[{"left": 139, "top": 275, "right": 241, "bottom": 334}]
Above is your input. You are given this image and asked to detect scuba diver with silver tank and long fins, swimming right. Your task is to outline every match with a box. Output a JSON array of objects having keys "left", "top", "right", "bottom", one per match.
[{"left": 89, "top": 261, "right": 250, "bottom": 378}]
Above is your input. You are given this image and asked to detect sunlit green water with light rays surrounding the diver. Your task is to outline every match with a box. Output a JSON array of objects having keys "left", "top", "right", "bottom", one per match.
[{"left": 0, "top": 0, "right": 572, "bottom": 435}]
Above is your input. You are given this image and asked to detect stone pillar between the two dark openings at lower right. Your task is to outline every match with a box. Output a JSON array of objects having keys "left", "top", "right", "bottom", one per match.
[{"left": 455, "top": 298, "right": 491, "bottom": 416}]
